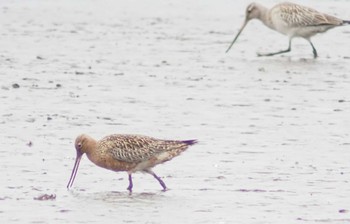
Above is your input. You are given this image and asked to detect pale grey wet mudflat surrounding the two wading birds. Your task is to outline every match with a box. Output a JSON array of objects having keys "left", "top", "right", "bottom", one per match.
[{"left": 0, "top": 0, "right": 350, "bottom": 223}]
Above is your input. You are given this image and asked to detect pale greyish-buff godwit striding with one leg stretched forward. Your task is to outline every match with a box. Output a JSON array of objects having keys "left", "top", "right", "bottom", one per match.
[{"left": 226, "top": 2, "right": 350, "bottom": 58}]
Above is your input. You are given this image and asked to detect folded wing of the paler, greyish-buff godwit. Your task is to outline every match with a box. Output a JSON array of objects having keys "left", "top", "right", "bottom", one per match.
[{"left": 275, "top": 3, "right": 343, "bottom": 27}]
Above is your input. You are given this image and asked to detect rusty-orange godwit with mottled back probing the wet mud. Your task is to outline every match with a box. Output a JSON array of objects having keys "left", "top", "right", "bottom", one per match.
[{"left": 67, "top": 134, "right": 197, "bottom": 193}]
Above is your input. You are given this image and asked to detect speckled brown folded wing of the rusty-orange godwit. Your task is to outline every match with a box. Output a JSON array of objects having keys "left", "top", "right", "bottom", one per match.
[{"left": 99, "top": 135, "right": 179, "bottom": 162}]
